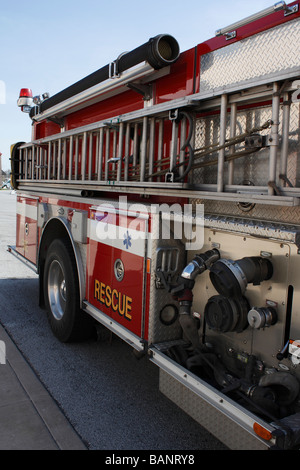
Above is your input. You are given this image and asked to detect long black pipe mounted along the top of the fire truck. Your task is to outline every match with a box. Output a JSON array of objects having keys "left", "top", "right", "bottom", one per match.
[{"left": 40, "top": 34, "right": 180, "bottom": 112}]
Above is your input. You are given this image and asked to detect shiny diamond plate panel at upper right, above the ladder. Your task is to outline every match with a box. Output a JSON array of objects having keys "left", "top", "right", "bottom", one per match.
[{"left": 200, "top": 20, "right": 300, "bottom": 92}]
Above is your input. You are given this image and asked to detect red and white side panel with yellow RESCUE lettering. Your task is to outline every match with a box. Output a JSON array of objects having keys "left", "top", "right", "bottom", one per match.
[{"left": 87, "top": 208, "right": 147, "bottom": 337}]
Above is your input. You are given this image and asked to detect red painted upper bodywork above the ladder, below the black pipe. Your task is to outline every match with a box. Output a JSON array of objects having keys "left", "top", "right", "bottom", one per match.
[{"left": 34, "top": 2, "right": 300, "bottom": 139}]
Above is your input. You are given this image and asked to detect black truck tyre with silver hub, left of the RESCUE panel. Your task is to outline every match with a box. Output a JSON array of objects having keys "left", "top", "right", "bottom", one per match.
[{"left": 44, "top": 239, "right": 93, "bottom": 343}]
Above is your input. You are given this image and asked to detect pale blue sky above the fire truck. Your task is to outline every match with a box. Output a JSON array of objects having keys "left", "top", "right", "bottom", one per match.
[{"left": 0, "top": 0, "right": 274, "bottom": 170}]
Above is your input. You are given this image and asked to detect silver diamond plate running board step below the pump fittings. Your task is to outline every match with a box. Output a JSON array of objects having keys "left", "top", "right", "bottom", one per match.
[{"left": 149, "top": 345, "right": 275, "bottom": 450}]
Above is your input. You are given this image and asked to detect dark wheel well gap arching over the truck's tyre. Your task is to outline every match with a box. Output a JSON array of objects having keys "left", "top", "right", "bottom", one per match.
[{"left": 38, "top": 218, "right": 72, "bottom": 307}]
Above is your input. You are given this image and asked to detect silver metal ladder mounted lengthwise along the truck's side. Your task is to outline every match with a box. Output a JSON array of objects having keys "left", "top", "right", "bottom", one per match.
[{"left": 15, "top": 75, "right": 297, "bottom": 206}]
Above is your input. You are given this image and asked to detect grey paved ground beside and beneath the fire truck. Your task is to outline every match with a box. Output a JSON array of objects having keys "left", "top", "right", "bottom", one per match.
[{"left": 0, "top": 191, "right": 224, "bottom": 452}]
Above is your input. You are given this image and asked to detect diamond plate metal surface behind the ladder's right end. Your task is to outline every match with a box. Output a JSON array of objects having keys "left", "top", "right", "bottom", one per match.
[{"left": 193, "top": 103, "right": 300, "bottom": 187}]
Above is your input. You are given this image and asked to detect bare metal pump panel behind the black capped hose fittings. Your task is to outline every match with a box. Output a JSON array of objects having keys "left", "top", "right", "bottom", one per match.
[{"left": 190, "top": 229, "right": 290, "bottom": 367}]
